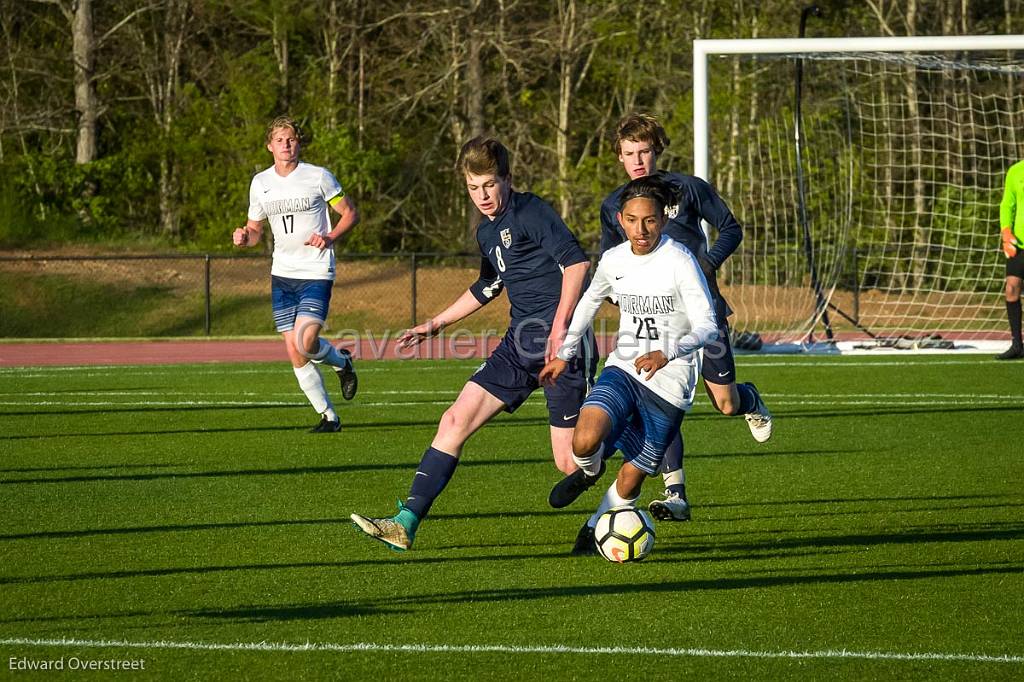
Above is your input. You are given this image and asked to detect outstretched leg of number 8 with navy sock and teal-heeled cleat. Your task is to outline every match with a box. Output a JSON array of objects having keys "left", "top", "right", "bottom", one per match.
[{"left": 351, "top": 381, "right": 505, "bottom": 551}]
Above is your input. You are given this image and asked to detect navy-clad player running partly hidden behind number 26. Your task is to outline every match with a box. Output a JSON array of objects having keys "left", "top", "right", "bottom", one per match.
[{"left": 551, "top": 114, "right": 772, "bottom": 521}]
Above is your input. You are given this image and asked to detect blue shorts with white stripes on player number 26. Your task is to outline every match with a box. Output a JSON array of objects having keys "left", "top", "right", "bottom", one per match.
[{"left": 583, "top": 367, "right": 686, "bottom": 476}]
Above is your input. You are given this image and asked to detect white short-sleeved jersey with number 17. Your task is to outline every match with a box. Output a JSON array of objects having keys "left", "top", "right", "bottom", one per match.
[{"left": 249, "top": 162, "right": 344, "bottom": 280}]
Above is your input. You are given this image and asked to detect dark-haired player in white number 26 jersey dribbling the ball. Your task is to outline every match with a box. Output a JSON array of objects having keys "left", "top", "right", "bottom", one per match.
[{"left": 540, "top": 176, "right": 718, "bottom": 554}]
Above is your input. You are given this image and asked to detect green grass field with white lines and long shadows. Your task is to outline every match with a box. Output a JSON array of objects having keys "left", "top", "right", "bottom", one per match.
[{"left": 0, "top": 355, "right": 1024, "bottom": 681}]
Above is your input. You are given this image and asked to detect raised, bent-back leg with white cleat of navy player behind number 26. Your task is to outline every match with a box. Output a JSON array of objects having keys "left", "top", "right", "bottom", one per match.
[{"left": 700, "top": 323, "right": 773, "bottom": 442}]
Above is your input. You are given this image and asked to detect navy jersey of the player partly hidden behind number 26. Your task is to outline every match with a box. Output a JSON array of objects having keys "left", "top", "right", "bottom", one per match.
[{"left": 601, "top": 171, "right": 743, "bottom": 269}]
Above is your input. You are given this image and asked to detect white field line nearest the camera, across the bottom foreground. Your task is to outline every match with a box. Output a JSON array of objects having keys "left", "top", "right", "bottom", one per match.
[{"left": 0, "top": 638, "right": 1024, "bottom": 665}]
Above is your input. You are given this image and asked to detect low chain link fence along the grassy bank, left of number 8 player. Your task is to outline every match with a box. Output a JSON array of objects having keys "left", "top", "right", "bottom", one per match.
[{"left": 0, "top": 253, "right": 614, "bottom": 339}]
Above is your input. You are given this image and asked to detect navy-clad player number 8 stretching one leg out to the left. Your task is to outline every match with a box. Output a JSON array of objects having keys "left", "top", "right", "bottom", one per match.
[{"left": 351, "top": 137, "right": 597, "bottom": 550}]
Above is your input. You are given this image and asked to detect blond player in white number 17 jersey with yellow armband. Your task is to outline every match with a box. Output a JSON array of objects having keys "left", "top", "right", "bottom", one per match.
[{"left": 231, "top": 116, "right": 359, "bottom": 433}]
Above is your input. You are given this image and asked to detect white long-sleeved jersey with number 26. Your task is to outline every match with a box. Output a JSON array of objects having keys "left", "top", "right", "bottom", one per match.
[{"left": 558, "top": 236, "right": 718, "bottom": 403}]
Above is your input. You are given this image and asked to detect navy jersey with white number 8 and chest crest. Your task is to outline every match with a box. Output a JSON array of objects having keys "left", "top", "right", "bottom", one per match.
[{"left": 470, "top": 191, "right": 587, "bottom": 328}]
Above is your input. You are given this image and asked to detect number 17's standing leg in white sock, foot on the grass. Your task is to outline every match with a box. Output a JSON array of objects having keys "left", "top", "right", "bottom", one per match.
[{"left": 270, "top": 276, "right": 341, "bottom": 433}]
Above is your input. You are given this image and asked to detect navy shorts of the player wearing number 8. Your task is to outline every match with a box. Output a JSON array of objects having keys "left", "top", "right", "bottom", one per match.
[{"left": 469, "top": 330, "right": 597, "bottom": 428}]
